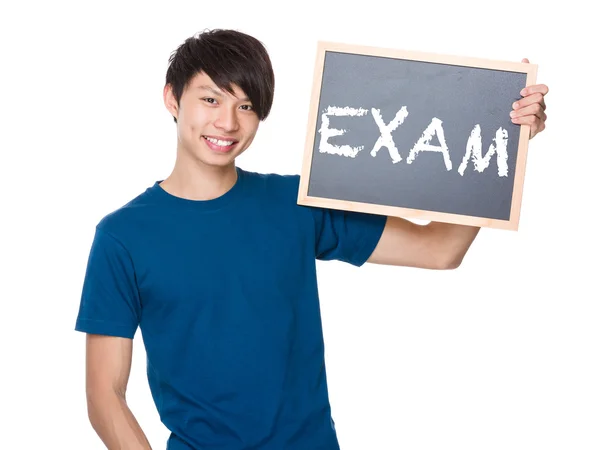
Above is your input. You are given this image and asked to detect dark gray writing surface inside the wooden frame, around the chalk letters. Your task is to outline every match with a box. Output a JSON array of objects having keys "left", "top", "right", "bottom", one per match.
[{"left": 308, "top": 51, "right": 527, "bottom": 220}]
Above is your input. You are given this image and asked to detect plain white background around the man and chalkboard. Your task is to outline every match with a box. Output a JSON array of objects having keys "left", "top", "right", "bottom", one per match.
[{"left": 0, "top": 0, "right": 600, "bottom": 450}]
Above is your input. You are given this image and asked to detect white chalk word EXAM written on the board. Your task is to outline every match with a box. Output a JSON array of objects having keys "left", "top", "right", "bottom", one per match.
[{"left": 318, "top": 106, "right": 508, "bottom": 177}]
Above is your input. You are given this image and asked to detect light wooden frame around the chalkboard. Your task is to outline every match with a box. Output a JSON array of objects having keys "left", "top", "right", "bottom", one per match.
[{"left": 298, "top": 41, "right": 537, "bottom": 230}]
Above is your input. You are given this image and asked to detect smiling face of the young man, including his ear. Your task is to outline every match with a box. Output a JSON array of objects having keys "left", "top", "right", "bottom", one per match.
[{"left": 164, "top": 72, "right": 260, "bottom": 167}]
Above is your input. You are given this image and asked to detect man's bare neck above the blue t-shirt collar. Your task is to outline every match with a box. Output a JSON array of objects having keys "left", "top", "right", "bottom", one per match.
[{"left": 160, "top": 152, "right": 237, "bottom": 200}]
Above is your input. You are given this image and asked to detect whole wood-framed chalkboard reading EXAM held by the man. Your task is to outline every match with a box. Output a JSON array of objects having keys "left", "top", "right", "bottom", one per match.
[{"left": 298, "top": 42, "right": 537, "bottom": 230}]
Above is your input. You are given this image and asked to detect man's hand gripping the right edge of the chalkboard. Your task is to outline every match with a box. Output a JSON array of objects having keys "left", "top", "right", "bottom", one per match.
[{"left": 510, "top": 58, "right": 548, "bottom": 139}]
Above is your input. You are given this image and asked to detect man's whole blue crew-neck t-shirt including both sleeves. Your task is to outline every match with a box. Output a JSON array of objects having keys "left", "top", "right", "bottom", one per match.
[{"left": 76, "top": 168, "right": 385, "bottom": 450}]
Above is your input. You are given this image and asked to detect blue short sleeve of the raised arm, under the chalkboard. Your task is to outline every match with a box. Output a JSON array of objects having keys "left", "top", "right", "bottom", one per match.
[{"left": 312, "top": 208, "right": 387, "bottom": 267}]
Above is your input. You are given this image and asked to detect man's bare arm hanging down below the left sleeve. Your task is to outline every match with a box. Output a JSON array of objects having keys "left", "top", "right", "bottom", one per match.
[{"left": 86, "top": 334, "right": 151, "bottom": 450}]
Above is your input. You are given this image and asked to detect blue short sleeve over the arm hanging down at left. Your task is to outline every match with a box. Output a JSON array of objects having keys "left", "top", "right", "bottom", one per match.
[{"left": 75, "top": 227, "right": 141, "bottom": 339}]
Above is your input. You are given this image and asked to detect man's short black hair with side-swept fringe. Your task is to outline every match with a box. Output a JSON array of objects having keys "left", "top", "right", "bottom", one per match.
[{"left": 166, "top": 29, "right": 275, "bottom": 122}]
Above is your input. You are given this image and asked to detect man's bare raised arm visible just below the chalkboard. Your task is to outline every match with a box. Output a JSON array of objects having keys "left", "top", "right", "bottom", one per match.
[{"left": 367, "top": 217, "right": 479, "bottom": 270}]
